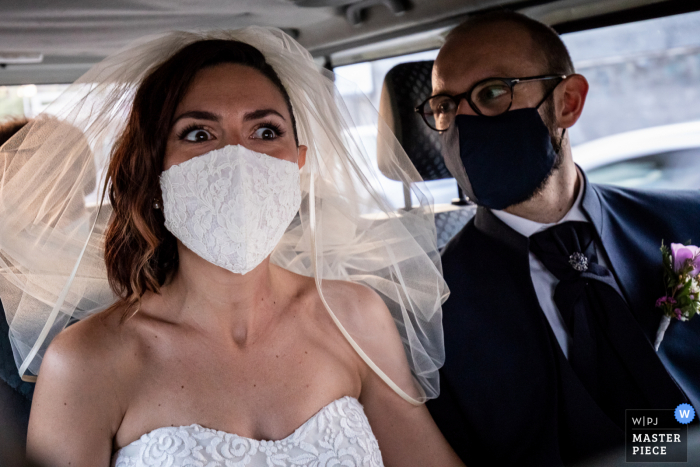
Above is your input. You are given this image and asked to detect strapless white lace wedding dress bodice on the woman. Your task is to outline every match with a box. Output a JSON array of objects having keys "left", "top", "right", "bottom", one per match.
[{"left": 112, "top": 396, "right": 384, "bottom": 467}]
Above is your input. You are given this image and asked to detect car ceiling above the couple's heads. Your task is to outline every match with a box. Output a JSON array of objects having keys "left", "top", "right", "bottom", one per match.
[{"left": 0, "top": 0, "right": 688, "bottom": 85}]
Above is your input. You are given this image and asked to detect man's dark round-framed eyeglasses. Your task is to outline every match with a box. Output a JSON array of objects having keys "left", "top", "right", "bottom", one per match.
[{"left": 415, "top": 75, "right": 566, "bottom": 131}]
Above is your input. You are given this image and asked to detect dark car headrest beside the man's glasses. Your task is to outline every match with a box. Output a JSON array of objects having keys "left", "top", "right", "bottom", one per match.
[{"left": 377, "top": 61, "right": 452, "bottom": 181}]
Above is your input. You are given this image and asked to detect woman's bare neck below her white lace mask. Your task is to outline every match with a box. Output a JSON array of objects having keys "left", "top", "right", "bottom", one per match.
[{"left": 161, "top": 247, "right": 281, "bottom": 347}]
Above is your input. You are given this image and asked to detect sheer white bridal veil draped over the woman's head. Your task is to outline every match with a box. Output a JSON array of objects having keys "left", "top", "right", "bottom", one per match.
[{"left": 0, "top": 27, "right": 448, "bottom": 404}]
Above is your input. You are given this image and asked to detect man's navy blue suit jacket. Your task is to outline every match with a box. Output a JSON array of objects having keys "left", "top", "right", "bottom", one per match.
[{"left": 428, "top": 178, "right": 700, "bottom": 466}]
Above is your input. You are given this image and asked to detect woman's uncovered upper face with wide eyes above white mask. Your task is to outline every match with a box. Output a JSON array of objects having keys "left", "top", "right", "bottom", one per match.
[{"left": 163, "top": 64, "right": 306, "bottom": 170}]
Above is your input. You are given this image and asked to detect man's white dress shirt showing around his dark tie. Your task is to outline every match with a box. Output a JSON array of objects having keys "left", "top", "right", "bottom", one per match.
[{"left": 491, "top": 177, "right": 607, "bottom": 358}]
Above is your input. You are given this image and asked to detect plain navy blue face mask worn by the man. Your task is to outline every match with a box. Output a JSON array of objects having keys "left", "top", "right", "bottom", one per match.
[{"left": 443, "top": 108, "right": 557, "bottom": 209}]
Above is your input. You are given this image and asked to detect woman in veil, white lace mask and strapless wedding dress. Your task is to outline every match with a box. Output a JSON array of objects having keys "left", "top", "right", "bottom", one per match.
[{"left": 0, "top": 28, "right": 461, "bottom": 467}]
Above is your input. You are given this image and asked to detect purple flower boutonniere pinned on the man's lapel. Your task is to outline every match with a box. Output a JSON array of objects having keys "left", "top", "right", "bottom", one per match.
[{"left": 654, "top": 241, "right": 700, "bottom": 350}]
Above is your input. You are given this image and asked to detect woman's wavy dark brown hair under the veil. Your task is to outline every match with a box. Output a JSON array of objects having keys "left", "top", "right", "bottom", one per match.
[{"left": 105, "top": 40, "right": 298, "bottom": 313}]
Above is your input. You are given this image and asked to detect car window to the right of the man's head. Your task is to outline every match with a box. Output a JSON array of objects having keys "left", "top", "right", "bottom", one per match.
[{"left": 562, "top": 8, "right": 700, "bottom": 189}]
